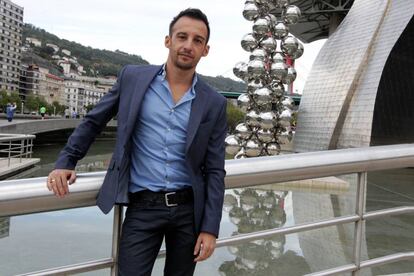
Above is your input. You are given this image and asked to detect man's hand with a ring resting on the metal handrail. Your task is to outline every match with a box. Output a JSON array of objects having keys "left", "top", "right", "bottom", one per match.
[{"left": 47, "top": 169, "right": 76, "bottom": 198}]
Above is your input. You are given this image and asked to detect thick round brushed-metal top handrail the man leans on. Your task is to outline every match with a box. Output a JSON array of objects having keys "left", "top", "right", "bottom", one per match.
[{"left": 0, "top": 144, "right": 414, "bottom": 217}]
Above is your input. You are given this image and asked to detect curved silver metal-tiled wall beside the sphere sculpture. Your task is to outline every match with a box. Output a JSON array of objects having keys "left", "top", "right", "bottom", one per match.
[{"left": 294, "top": 0, "right": 414, "bottom": 152}]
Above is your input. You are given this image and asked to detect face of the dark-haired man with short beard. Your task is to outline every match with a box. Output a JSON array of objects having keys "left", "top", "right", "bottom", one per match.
[{"left": 165, "top": 16, "right": 210, "bottom": 70}]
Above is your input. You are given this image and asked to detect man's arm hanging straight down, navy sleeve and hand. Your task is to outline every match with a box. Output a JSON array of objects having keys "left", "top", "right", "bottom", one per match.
[{"left": 194, "top": 100, "right": 227, "bottom": 262}]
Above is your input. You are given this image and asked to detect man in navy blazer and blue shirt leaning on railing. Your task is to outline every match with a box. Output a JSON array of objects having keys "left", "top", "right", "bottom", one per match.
[{"left": 47, "top": 9, "right": 227, "bottom": 275}]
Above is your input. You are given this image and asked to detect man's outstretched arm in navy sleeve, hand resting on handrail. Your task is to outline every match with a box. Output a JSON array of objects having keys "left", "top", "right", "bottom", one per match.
[{"left": 47, "top": 67, "right": 126, "bottom": 197}]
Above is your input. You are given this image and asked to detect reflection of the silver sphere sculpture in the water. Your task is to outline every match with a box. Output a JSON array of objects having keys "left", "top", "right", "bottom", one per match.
[{"left": 219, "top": 188, "right": 310, "bottom": 276}]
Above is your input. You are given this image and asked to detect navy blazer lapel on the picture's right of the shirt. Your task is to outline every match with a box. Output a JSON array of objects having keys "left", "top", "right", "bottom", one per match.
[{"left": 185, "top": 85, "right": 207, "bottom": 153}]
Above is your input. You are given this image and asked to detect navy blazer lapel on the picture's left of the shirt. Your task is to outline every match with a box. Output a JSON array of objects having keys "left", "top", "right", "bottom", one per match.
[{"left": 125, "top": 66, "right": 161, "bottom": 138}]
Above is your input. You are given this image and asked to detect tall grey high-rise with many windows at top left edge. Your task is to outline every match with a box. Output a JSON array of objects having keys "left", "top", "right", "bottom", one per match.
[{"left": 0, "top": 0, "right": 23, "bottom": 91}]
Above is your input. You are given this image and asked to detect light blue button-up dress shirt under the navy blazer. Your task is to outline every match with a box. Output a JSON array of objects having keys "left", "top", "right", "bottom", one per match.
[{"left": 129, "top": 65, "right": 197, "bottom": 193}]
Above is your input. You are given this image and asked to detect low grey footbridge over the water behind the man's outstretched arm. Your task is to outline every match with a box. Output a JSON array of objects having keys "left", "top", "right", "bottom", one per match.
[{"left": 0, "top": 119, "right": 117, "bottom": 134}]
